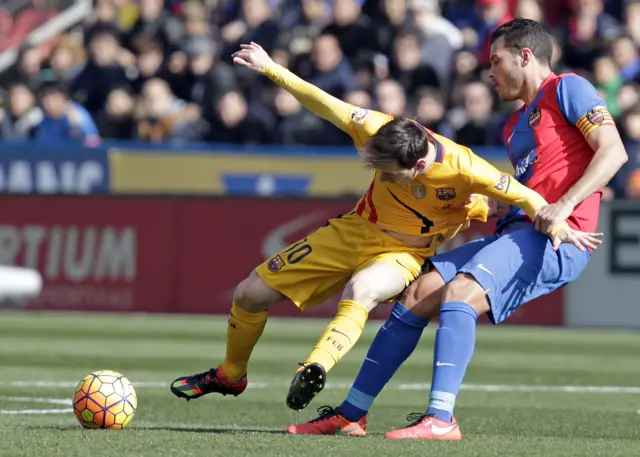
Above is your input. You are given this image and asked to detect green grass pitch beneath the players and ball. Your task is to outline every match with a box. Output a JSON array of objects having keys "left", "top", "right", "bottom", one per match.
[{"left": 0, "top": 312, "right": 640, "bottom": 457}]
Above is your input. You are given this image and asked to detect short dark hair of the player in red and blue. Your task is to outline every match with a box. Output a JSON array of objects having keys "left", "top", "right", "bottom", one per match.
[{"left": 490, "top": 18, "right": 553, "bottom": 64}]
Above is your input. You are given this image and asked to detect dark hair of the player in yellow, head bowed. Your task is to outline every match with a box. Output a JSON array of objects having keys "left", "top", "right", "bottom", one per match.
[{"left": 366, "top": 117, "right": 429, "bottom": 169}]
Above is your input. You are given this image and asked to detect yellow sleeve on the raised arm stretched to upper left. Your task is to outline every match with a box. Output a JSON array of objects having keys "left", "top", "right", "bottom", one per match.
[{"left": 262, "top": 64, "right": 393, "bottom": 147}]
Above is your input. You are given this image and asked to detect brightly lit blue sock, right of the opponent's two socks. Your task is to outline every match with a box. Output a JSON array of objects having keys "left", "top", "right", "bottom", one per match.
[{"left": 427, "top": 302, "right": 478, "bottom": 422}]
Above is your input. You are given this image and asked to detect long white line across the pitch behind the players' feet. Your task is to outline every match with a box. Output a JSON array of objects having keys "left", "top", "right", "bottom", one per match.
[{"left": 8, "top": 381, "right": 640, "bottom": 394}]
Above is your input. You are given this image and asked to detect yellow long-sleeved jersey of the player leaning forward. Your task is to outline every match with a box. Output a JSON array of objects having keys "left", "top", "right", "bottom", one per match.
[{"left": 262, "top": 64, "right": 547, "bottom": 247}]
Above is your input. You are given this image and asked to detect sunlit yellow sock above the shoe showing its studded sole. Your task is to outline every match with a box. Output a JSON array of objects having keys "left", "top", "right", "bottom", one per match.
[{"left": 305, "top": 300, "right": 369, "bottom": 371}]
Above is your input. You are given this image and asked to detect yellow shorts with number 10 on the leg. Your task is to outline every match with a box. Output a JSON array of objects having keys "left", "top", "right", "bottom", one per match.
[{"left": 256, "top": 214, "right": 434, "bottom": 311}]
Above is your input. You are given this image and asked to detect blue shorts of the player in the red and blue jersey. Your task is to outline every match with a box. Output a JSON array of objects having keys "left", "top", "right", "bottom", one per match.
[{"left": 430, "top": 221, "right": 591, "bottom": 324}]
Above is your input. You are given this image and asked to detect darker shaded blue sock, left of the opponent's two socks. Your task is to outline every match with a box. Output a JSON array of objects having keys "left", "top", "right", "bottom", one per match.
[{"left": 340, "top": 301, "right": 429, "bottom": 422}]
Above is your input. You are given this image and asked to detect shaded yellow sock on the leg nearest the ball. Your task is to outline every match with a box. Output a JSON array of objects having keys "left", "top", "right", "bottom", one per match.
[{"left": 222, "top": 303, "right": 267, "bottom": 381}]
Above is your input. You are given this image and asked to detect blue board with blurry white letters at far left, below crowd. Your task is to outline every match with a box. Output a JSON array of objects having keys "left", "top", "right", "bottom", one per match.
[{"left": 0, "top": 144, "right": 109, "bottom": 195}]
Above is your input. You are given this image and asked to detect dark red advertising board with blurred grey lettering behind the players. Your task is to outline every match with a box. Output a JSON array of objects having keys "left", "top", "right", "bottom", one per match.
[{"left": 0, "top": 196, "right": 563, "bottom": 325}]
